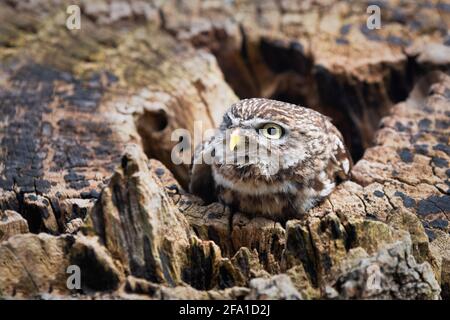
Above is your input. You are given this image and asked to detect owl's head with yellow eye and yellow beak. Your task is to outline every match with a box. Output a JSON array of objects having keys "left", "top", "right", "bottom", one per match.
[{"left": 206, "top": 98, "right": 332, "bottom": 180}]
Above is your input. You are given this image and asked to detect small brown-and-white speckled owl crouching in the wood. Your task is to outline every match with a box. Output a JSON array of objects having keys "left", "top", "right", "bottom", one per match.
[{"left": 190, "top": 98, "right": 352, "bottom": 220}]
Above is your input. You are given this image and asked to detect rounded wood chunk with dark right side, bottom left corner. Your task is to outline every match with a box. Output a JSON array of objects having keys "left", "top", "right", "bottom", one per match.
[{"left": 0, "top": 233, "right": 121, "bottom": 299}]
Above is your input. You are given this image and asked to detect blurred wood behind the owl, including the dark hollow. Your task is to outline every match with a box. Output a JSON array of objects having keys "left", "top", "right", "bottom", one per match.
[{"left": 162, "top": 0, "right": 450, "bottom": 159}]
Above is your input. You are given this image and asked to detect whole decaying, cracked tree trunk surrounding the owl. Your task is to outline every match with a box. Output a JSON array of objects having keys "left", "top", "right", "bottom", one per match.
[{"left": 0, "top": 1, "right": 450, "bottom": 299}]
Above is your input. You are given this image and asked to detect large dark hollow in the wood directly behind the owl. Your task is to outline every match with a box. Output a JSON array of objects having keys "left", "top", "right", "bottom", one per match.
[{"left": 201, "top": 35, "right": 416, "bottom": 162}]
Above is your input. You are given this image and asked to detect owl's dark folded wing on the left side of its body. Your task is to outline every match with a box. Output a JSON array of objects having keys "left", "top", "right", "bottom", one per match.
[{"left": 189, "top": 141, "right": 217, "bottom": 203}]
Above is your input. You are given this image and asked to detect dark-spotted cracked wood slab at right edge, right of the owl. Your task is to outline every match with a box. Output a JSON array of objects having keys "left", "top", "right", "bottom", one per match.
[{"left": 352, "top": 74, "right": 450, "bottom": 238}]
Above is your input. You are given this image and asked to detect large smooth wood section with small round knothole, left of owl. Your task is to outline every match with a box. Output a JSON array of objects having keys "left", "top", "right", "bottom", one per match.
[{"left": 0, "top": 3, "right": 237, "bottom": 233}]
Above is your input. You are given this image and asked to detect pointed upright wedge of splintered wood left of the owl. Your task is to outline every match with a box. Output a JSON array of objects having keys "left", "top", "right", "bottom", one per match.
[{"left": 84, "top": 145, "right": 190, "bottom": 286}]
